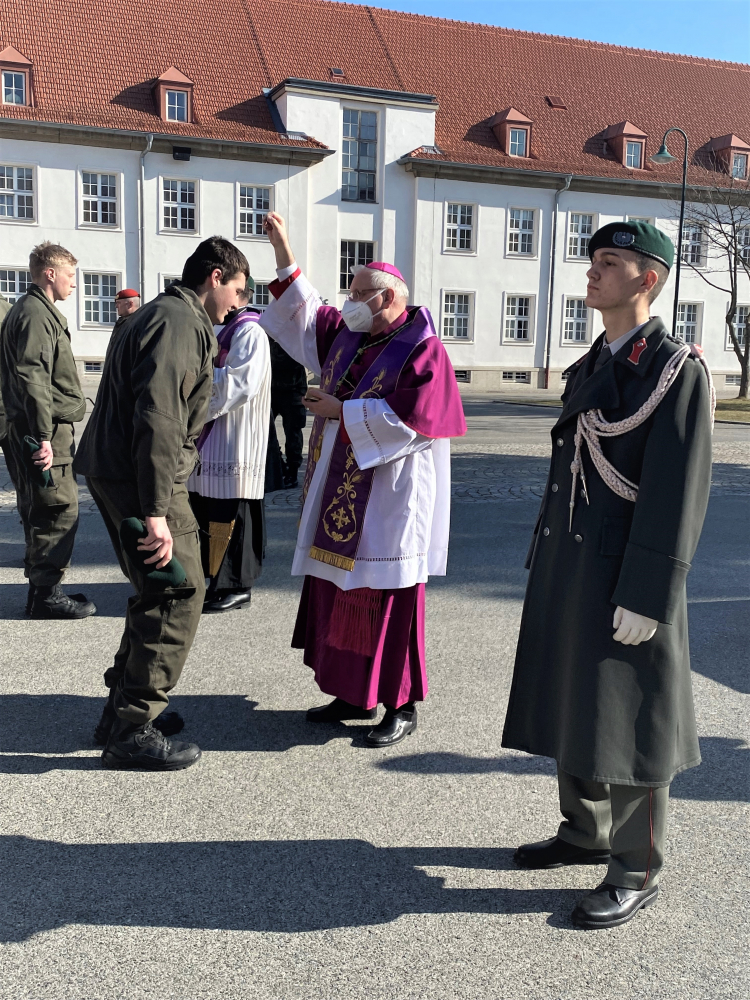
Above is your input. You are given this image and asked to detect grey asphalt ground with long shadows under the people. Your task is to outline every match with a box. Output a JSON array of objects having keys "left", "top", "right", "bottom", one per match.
[{"left": 0, "top": 397, "right": 750, "bottom": 1000}]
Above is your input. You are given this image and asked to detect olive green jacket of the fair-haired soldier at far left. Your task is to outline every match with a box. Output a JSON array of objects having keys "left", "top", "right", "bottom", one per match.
[{"left": 0, "top": 285, "right": 86, "bottom": 452}]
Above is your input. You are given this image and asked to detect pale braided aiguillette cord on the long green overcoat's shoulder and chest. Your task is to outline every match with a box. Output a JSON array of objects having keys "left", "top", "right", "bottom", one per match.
[{"left": 568, "top": 344, "right": 716, "bottom": 532}]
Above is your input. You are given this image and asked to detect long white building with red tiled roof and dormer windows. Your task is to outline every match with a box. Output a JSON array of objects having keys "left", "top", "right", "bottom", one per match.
[{"left": 0, "top": 13, "right": 750, "bottom": 388}]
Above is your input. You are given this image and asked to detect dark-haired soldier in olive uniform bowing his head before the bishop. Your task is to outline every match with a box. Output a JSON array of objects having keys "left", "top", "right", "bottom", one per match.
[{"left": 75, "top": 237, "right": 250, "bottom": 770}]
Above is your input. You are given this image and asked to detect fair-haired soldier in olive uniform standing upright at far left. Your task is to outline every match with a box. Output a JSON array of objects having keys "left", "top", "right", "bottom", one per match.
[{"left": 0, "top": 243, "right": 96, "bottom": 619}]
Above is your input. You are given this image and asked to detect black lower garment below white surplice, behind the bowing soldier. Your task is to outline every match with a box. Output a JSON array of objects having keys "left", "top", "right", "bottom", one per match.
[{"left": 190, "top": 493, "right": 266, "bottom": 592}]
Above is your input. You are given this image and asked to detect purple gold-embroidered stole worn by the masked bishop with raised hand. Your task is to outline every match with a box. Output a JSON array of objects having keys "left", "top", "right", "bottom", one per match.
[{"left": 302, "top": 309, "right": 435, "bottom": 572}]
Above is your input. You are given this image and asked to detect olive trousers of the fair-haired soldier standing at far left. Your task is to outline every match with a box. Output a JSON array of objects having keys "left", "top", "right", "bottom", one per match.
[{"left": 3, "top": 424, "right": 78, "bottom": 587}]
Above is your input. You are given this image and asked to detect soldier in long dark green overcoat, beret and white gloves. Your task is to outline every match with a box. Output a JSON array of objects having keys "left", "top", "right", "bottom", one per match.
[{"left": 503, "top": 222, "right": 712, "bottom": 928}]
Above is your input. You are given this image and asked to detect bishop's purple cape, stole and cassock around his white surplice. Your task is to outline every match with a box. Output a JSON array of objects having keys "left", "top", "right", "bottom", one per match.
[{"left": 270, "top": 272, "right": 466, "bottom": 709}]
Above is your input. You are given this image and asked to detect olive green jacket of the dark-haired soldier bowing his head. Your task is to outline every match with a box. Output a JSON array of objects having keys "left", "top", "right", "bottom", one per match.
[{"left": 73, "top": 284, "right": 217, "bottom": 517}]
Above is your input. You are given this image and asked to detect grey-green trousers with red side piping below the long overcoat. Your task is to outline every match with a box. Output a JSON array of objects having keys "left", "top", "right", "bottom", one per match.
[{"left": 557, "top": 767, "right": 669, "bottom": 889}]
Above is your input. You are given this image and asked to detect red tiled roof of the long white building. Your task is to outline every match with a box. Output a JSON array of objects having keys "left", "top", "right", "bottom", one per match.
[{"left": 0, "top": 0, "right": 750, "bottom": 184}]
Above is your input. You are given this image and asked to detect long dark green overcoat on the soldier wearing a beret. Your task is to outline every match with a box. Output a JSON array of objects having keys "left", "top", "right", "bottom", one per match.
[{"left": 502, "top": 318, "right": 711, "bottom": 786}]
